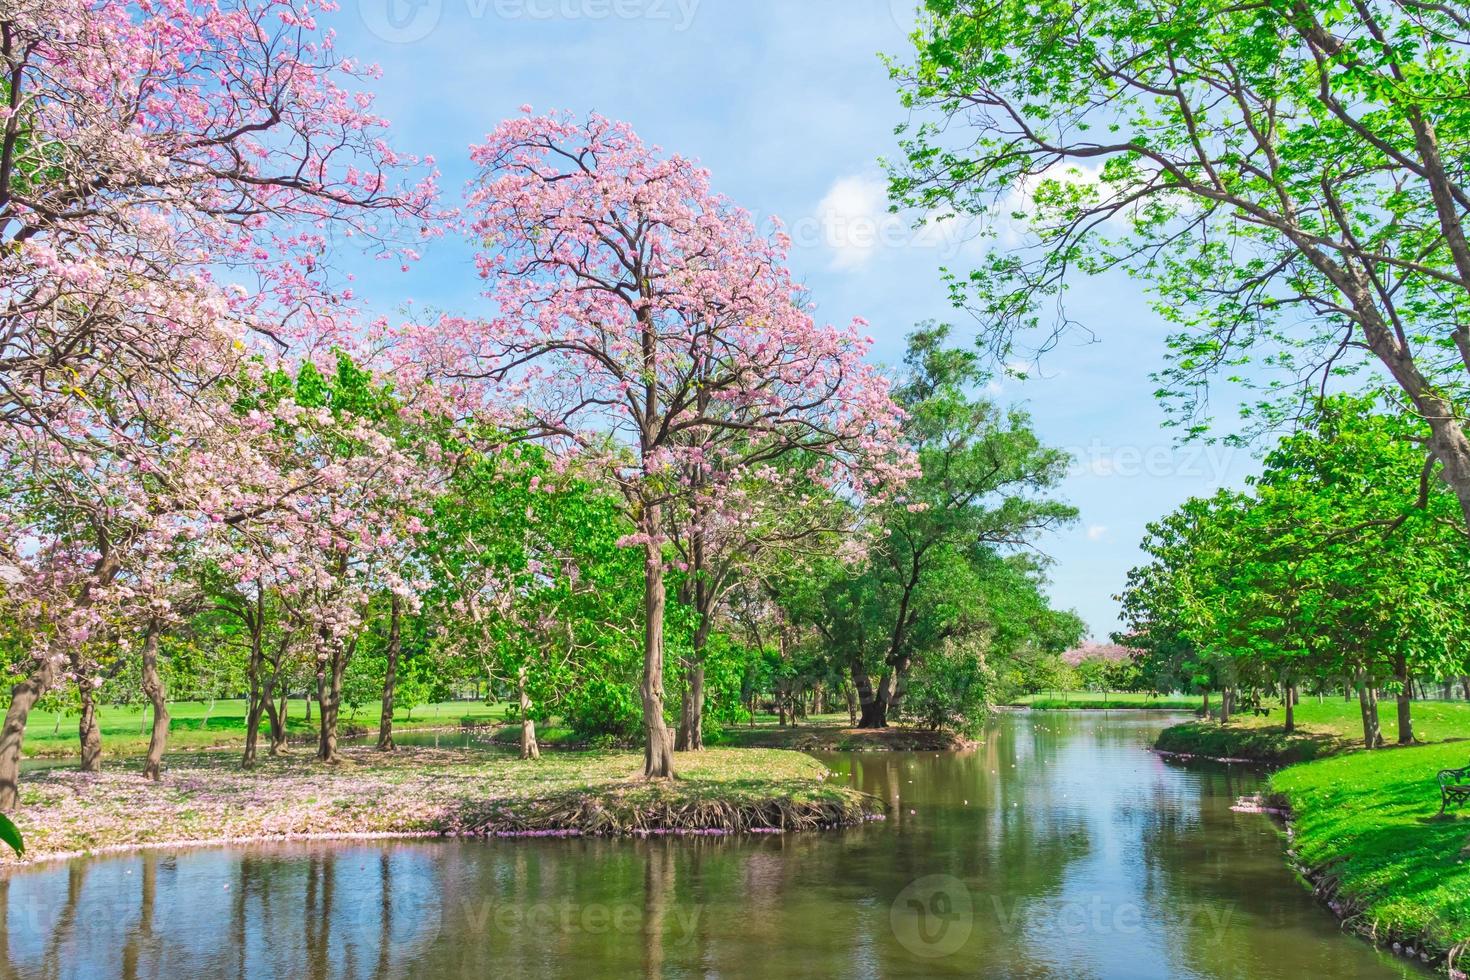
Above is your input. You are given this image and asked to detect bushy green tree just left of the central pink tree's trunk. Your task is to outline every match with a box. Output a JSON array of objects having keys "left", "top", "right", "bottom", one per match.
[{"left": 422, "top": 444, "right": 649, "bottom": 758}]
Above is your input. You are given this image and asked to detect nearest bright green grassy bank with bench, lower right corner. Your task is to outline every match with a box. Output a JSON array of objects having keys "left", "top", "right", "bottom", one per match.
[{"left": 1272, "top": 743, "right": 1470, "bottom": 965}]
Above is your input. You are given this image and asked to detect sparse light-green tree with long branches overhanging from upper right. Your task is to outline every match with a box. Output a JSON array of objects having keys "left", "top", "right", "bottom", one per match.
[{"left": 892, "top": 0, "right": 1470, "bottom": 520}]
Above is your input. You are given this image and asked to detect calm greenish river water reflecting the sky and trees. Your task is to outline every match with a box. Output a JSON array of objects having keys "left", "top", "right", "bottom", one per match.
[{"left": 0, "top": 711, "right": 1419, "bottom": 979}]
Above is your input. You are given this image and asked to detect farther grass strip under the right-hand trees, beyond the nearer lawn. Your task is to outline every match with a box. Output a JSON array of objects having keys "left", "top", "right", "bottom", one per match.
[{"left": 1155, "top": 698, "right": 1470, "bottom": 763}]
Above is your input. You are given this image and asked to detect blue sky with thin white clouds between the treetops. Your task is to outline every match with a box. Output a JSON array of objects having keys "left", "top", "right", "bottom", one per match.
[{"left": 326, "top": 0, "right": 1254, "bottom": 638}]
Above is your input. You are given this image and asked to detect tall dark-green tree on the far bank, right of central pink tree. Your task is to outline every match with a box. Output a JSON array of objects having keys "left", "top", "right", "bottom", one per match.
[{"left": 776, "top": 326, "right": 1080, "bottom": 727}]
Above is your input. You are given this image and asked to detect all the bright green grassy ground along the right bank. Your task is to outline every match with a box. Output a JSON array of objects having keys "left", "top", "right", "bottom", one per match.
[{"left": 1158, "top": 698, "right": 1470, "bottom": 976}]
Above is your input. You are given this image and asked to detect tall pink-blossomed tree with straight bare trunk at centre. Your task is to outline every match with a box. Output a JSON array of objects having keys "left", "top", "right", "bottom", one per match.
[{"left": 406, "top": 107, "right": 910, "bottom": 777}]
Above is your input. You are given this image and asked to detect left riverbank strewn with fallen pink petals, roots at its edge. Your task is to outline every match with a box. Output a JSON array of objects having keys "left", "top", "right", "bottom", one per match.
[{"left": 5, "top": 748, "right": 883, "bottom": 861}]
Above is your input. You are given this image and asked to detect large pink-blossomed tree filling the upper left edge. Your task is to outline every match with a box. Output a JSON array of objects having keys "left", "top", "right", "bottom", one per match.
[{"left": 0, "top": 0, "right": 437, "bottom": 811}]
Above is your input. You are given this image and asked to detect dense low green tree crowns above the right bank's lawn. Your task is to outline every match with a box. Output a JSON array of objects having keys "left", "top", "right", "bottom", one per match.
[{"left": 1120, "top": 397, "right": 1470, "bottom": 717}]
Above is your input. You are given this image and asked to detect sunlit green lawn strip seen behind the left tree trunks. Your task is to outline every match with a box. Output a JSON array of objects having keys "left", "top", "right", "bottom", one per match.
[{"left": 25, "top": 699, "right": 509, "bottom": 758}]
